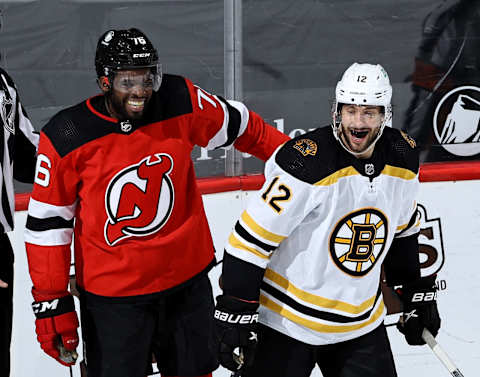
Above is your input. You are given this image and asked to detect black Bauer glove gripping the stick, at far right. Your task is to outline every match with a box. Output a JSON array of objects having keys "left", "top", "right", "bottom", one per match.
[{"left": 396, "top": 275, "right": 440, "bottom": 346}]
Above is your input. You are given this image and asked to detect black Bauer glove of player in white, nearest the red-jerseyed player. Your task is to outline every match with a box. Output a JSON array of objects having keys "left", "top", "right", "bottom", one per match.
[{"left": 213, "top": 295, "right": 258, "bottom": 371}]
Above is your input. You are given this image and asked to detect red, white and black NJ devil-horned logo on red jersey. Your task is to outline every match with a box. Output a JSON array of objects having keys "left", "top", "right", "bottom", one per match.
[{"left": 104, "top": 153, "right": 174, "bottom": 246}]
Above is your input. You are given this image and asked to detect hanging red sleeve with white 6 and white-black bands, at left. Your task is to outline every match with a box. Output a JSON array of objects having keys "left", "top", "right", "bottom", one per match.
[{"left": 25, "top": 132, "right": 78, "bottom": 294}]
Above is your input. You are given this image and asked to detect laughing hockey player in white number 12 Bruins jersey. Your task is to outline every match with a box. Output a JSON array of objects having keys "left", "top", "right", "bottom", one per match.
[{"left": 213, "top": 63, "right": 440, "bottom": 377}]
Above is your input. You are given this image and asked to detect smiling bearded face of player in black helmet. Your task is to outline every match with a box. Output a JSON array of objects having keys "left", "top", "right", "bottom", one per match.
[{"left": 102, "top": 68, "right": 154, "bottom": 120}]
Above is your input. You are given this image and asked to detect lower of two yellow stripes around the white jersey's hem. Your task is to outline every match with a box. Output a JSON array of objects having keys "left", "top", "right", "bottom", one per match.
[{"left": 260, "top": 295, "right": 385, "bottom": 333}]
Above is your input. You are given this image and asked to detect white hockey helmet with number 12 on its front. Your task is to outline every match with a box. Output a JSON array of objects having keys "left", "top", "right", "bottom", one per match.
[{"left": 332, "top": 63, "right": 392, "bottom": 156}]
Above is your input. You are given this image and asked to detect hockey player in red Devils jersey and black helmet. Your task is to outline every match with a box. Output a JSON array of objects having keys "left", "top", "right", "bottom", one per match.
[{"left": 25, "top": 29, "right": 288, "bottom": 377}]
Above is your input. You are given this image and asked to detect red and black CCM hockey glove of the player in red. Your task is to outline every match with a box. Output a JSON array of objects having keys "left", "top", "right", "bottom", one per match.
[{"left": 32, "top": 290, "right": 79, "bottom": 366}]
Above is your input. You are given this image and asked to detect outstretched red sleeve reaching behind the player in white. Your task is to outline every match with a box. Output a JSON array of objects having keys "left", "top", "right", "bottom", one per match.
[{"left": 187, "top": 81, "right": 289, "bottom": 161}]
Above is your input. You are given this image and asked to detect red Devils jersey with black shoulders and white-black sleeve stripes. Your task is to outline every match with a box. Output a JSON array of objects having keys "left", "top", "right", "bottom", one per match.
[{"left": 25, "top": 75, "right": 287, "bottom": 296}]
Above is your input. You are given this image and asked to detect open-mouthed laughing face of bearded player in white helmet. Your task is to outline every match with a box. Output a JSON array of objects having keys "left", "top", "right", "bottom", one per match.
[{"left": 340, "top": 104, "right": 384, "bottom": 158}]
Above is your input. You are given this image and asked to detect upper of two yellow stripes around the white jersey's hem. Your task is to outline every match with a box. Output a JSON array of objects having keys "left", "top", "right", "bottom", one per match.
[{"left": 265, "top": 268, "right": 376, "bottom": 314}]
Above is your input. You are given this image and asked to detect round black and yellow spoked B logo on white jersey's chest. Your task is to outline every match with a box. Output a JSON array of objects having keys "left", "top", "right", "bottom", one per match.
[{"left": 329, "top": 208, "right": 388, "bottom": 276}]
